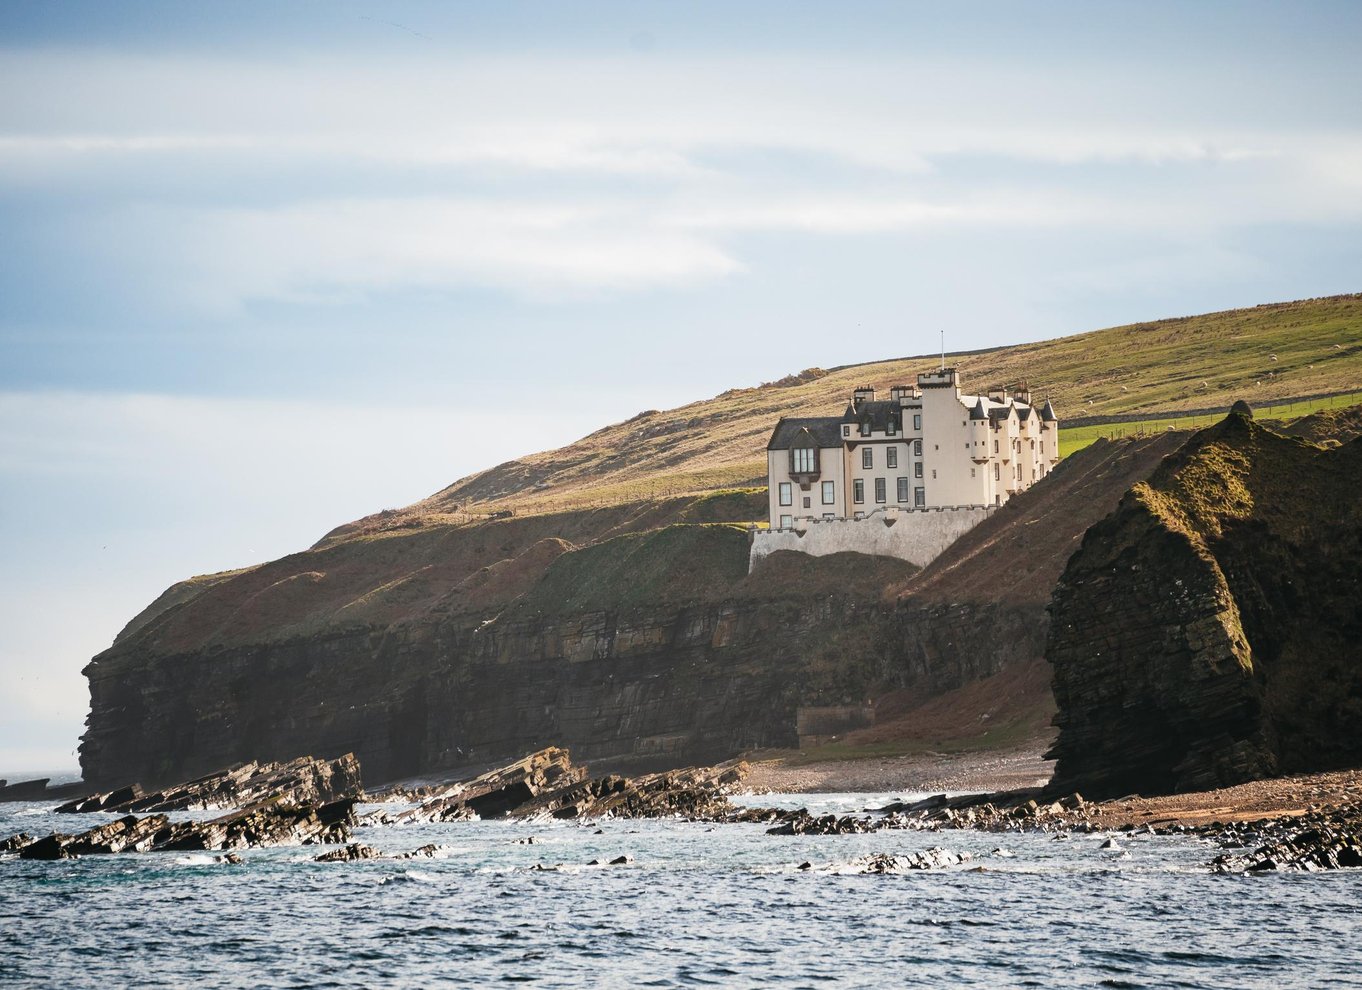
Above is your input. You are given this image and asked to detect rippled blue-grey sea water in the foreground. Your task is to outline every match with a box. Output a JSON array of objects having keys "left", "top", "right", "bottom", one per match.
[{"left": 0, "top": 794, "right": 1362, "bottom": 990}]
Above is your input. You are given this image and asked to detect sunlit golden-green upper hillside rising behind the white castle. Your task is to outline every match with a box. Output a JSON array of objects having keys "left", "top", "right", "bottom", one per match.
[{"left": 407, "top": 294, "right": 1362, "bottom": 513}]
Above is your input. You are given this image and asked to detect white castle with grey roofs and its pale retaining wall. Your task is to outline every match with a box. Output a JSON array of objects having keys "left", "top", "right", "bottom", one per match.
[{"left": 752, "top": 368, "right": 1060, "bottom": 565}]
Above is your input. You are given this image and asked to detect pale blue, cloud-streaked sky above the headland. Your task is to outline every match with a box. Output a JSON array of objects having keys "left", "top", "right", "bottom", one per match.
[{"left": 0, "top": 0, "right": 1362, "bottom": 775}]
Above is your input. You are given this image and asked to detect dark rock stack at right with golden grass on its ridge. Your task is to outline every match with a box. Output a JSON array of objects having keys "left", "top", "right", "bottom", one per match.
[{"left": 1046, "top": 414, "right": 1362, "bottom": 795}]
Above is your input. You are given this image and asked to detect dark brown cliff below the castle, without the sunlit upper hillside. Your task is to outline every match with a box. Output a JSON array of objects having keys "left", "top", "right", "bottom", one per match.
[{"left": 80, "top": 437, "right": 1175, "bottom": 786}]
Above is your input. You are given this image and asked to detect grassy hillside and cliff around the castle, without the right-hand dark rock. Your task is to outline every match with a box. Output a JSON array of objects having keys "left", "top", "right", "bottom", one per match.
[{"left": 80, "top": 296, "right": 1362, "bottom": 787}]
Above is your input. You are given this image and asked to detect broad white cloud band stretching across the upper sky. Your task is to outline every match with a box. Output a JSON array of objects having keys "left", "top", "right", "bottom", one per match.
[{"left": 0, "top": 49, "right": 1362, "bottom": 313}]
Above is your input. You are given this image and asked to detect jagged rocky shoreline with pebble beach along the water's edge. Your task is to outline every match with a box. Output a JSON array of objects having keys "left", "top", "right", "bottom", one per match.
[{"left": 0, "top": 748, "right": 1362, "bottom": 873}]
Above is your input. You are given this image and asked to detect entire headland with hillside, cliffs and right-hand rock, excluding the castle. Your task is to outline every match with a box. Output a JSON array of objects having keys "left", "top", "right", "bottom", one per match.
[{"left": 39, "top": 296, "right": 1362, "bottom": 871}]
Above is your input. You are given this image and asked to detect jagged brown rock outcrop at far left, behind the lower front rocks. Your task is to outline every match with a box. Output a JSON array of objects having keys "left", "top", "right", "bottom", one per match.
[{"left": 54, "top": 753, "right": 362, "bottom": 813}]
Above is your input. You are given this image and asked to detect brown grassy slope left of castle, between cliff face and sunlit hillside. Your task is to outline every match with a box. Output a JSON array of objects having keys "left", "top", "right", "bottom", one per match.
[{"left": 106, "top": 493, "right": 764, "bottom": 656}]
